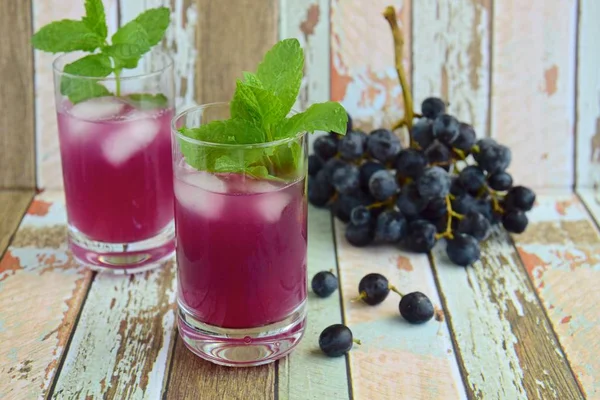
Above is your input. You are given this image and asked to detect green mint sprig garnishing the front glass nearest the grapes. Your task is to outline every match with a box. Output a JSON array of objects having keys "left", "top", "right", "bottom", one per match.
[{"left": 179, "top": 39, "right": 348, "bottom": 179}]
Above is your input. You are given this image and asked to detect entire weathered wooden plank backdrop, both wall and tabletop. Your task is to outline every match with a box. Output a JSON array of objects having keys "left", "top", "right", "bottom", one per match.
[{"left": 0, "top": 0, "right": 600, "bottom": 400}]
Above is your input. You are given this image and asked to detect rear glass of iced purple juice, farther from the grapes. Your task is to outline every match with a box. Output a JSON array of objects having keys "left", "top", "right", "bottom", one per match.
[{"left": 54, "top": 52, "right": 175, "bottom": 273}]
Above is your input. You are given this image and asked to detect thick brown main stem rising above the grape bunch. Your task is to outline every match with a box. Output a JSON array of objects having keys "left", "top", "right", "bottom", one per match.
[{"left": 383, "top": 6, "right": 415, "bottom": 147}]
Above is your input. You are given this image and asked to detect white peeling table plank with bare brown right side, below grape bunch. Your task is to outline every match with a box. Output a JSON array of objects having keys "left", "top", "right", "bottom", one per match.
[{"left": 433, "top": 229, "right": 581, "bottom": 399}]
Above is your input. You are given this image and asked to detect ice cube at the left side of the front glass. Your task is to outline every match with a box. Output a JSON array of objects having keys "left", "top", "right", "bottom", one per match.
[{"left": 175, "top": 172, "right": 226, "bottom": 219}]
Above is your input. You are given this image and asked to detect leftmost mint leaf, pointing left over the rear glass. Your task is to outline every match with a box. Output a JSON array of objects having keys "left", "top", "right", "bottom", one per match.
[{"left": 31, "top": 19, "right": 104, "bottom": 53}]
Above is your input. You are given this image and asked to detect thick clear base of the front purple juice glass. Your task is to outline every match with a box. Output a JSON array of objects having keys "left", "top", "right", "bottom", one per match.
[{"left": 178, "top": 301, "right": 306, "bottom": 367}]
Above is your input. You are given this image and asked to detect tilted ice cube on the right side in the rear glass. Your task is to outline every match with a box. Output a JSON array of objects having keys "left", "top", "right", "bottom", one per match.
[{"left": 102, "top": 119, "right": 160, "bottom": 166}]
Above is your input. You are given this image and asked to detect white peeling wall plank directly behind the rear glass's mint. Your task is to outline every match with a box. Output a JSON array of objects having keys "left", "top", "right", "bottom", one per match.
[{"left": 119, "top": 0, "right": 198, "bottom": 109}]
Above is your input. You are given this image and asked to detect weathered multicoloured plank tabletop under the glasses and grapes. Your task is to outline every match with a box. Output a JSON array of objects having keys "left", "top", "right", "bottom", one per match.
[{"left": 0, "top": 191, "right": 600, "bottom": 400}]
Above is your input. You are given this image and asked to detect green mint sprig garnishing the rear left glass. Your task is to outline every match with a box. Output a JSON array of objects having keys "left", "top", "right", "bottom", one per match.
[{"left": 32, "top": 0, "right": 170, "bottom": 104}]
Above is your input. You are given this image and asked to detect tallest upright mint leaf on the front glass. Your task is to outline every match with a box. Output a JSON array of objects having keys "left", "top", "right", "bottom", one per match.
[{"left": 256, "top": 39, "right": 304, "bottom": 116}]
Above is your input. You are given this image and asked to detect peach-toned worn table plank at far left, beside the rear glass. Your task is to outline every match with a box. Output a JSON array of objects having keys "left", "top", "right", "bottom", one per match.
[{"left": 0, "top": 192, "right": 92, "bottom": 399}]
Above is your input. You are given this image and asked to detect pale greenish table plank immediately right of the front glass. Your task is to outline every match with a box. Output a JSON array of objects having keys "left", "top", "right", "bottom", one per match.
[{"left": 279, "top": 206, "right": 349, "bottom": 400}]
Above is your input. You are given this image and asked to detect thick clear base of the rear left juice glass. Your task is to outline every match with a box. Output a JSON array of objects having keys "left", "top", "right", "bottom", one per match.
[{"left": 69, "top": 222, "right": 175, "bottom": 274}]
